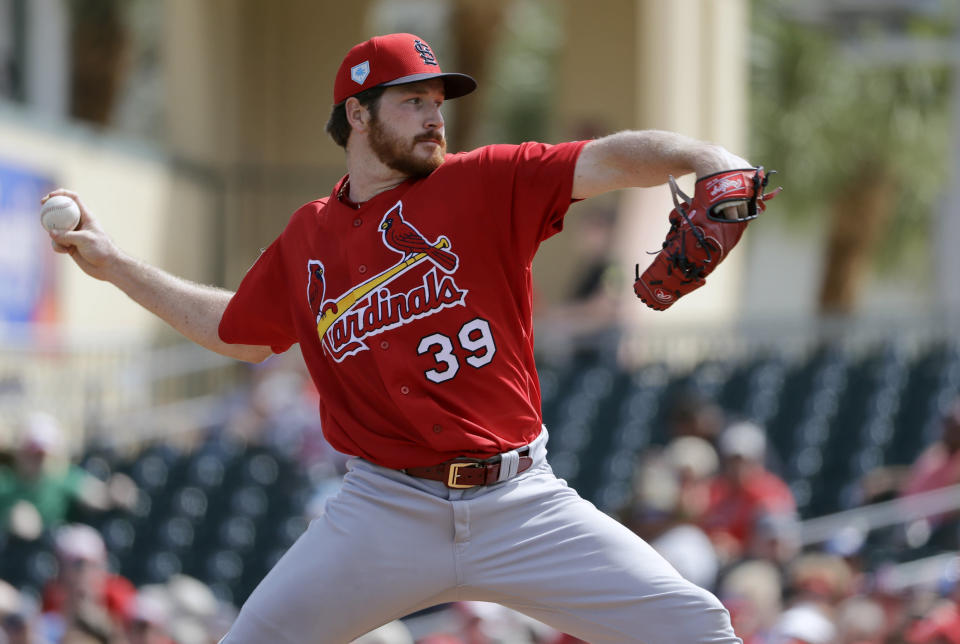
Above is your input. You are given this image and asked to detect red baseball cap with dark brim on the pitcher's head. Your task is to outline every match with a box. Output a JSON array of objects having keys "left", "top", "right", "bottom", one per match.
[{"left": 333, "top": 34, "right": 477, "bottom": 104}]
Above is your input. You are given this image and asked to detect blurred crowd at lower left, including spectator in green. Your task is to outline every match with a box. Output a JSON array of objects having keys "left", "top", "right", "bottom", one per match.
[{"left": 0, "top": 413, "right": 235, "bottom": 644}]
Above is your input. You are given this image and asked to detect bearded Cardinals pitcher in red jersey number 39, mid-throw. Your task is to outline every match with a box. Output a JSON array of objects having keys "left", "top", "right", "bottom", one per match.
[{"left": 51, "top": 33, "right": 769, "bottom": 644}]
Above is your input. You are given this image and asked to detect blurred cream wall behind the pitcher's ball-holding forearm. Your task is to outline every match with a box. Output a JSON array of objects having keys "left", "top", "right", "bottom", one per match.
[{"left": 0, "top": 111, "right": 216, "bottom": 341}]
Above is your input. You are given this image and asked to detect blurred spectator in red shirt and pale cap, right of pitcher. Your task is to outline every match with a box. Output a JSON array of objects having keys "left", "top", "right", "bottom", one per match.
[{"left": 700, "top": 422, "right": 796, "bottom": 561}]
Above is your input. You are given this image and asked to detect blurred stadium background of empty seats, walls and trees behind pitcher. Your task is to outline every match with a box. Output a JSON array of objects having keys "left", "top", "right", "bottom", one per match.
[{"left": 0, "top": 0, "right": 960, "bottom": 641}]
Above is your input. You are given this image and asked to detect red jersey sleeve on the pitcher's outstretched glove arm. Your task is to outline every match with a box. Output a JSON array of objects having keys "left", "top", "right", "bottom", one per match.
[{"left": 470, "top": 141, "right": 588, "bottom": 257}]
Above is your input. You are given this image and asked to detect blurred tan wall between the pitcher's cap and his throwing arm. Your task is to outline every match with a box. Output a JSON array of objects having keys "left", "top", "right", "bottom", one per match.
[{"left": 166, "top": 0, "right": 370, "bottom": 287}]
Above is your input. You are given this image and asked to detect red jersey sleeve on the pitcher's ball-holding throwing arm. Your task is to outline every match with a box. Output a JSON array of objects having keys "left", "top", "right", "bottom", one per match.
[{"left": 219, "top": 236, "right": 297, "bottom": 353}]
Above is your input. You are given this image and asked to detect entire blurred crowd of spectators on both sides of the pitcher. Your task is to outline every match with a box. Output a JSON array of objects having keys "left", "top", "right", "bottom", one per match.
[{"left": 0, "top": 361, "right": 960, "bottom": 644}]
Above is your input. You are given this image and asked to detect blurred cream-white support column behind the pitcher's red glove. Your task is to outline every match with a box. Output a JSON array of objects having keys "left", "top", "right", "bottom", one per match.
[{"left": 617, "top": 0, "right": 749, "bottom": 327}]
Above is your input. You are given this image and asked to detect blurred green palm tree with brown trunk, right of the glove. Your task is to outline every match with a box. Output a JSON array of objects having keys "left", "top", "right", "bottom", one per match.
[{"left": 752, "top": 0, "right": 952, "bottom": 315}]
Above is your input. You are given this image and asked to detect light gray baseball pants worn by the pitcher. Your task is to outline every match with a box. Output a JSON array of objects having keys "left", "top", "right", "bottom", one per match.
[{"left": 222, "top": 430, "right": 740, "bottom": 644}]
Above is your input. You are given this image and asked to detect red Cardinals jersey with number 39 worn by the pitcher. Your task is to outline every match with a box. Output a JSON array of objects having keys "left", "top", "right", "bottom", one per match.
[{"left": 220, "top": 141, "right": 586, "bottom": 468}]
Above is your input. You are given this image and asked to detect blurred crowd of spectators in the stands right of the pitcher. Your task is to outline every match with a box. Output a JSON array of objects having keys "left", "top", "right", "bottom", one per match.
[{"left": 621, "top": 397, "right": 960, "bottom": 644}]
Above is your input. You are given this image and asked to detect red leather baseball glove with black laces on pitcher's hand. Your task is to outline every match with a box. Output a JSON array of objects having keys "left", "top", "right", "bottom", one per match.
[{"left": 633, "top": 166, "right": 781, "bottom": 311}]
